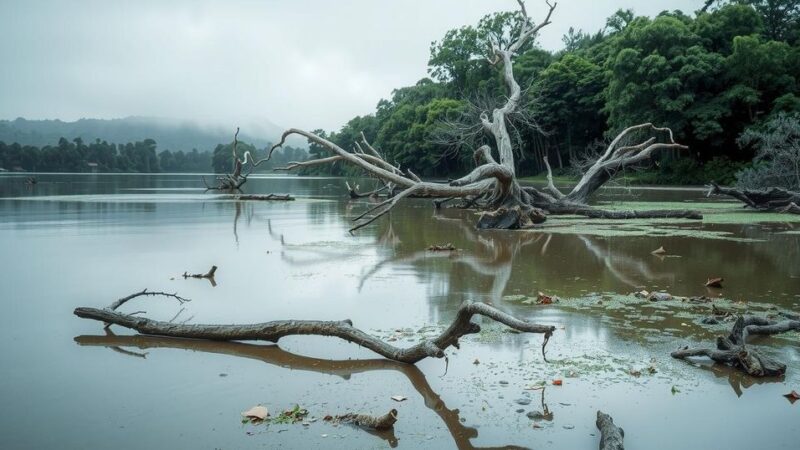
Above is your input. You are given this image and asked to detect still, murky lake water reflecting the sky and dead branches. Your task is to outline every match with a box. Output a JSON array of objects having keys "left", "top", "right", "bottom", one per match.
[{"left": 0, "top": 174, "right": 800, "bottom": 449}]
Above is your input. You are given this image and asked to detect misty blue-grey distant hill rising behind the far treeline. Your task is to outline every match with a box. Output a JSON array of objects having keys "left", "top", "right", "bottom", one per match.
[{"left": 0, "top": 117, "right": 306, "bottom": 152}]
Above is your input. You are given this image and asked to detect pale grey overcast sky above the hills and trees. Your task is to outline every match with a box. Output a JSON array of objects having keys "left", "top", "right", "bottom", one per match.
[{"left": 0, "top": 0, "right": 703, "bottom": 130}]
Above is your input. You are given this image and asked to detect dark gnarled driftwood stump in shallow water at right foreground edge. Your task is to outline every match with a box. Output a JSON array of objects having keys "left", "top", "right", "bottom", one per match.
[{"left": 672, "top": 315, "right": 800, "bottom": 377}]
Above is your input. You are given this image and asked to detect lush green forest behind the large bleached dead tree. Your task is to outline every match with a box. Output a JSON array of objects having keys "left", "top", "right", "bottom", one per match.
[{"left": 296, "top": 0, "right": 800, "bottom": 183}]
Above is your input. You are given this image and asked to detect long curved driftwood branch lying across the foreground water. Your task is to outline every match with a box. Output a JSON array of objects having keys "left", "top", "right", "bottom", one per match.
[{"left": 74, "top": 294, "right": 555, "bottom": 364}]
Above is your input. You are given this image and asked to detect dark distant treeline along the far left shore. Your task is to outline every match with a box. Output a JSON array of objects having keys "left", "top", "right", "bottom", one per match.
[{"left": 0, "top": 137, "right": 307, "bottom": 173}]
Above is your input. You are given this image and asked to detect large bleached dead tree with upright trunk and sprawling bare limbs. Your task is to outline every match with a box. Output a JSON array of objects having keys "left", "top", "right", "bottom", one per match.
[{"left": 266, "top": 0, "right": 702, "bottom": 231}]
